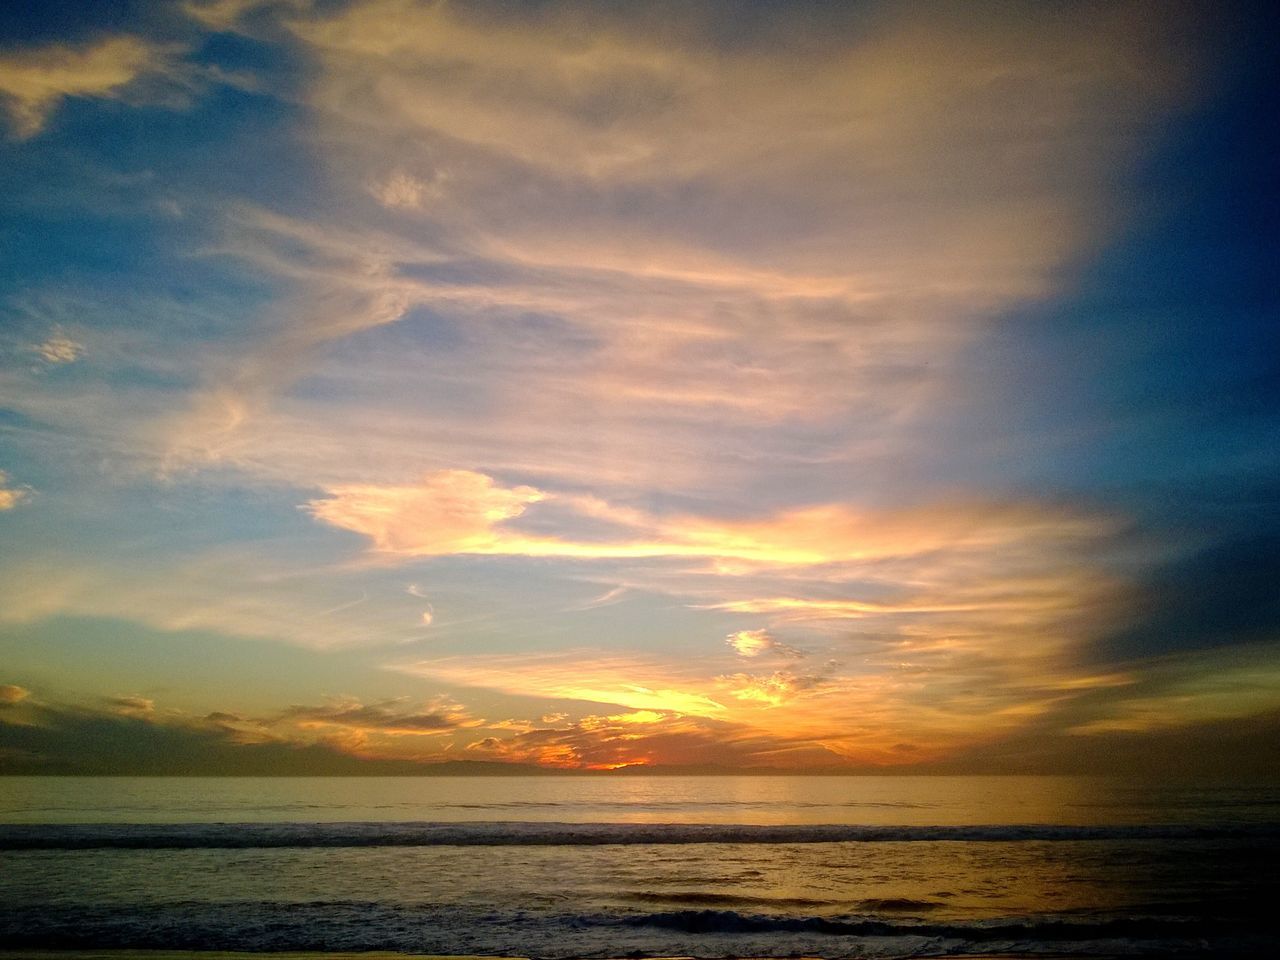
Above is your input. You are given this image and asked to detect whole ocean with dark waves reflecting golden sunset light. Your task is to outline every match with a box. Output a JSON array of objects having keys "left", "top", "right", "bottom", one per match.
[{"left": 0, "top": 774, "right": 1280, "bottom": 957}]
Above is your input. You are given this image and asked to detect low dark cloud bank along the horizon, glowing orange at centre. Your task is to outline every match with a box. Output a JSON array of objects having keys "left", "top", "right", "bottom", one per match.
[{"left": 0, "top": 685, "right": 1280, "bottom": 776}]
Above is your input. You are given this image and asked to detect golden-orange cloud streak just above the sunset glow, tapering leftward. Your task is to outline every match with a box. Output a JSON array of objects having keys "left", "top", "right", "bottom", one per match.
[{"left": 388, "top": 635, "right": 1116, "bottom": 767}]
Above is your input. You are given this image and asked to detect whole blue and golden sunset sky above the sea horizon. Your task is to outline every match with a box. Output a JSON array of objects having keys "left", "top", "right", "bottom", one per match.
[{"left": 0, "top": 0, "right": 1280, "bottom": 776}]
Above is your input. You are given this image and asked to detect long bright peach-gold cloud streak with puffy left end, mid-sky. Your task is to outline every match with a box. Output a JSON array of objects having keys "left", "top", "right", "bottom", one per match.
[{"left": 306, "top": 470, "right": 1114, "bottom": 572}]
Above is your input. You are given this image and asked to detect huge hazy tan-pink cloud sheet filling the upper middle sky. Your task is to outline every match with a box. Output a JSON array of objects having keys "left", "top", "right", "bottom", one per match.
[{"left": 154, "top": 0, "right": 1188, "bottom": 493}]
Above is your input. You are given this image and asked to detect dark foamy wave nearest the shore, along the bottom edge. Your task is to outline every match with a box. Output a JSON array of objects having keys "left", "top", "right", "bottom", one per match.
[{"left": 0, "top": 901, "right": 1274, "bottom": 959}]
